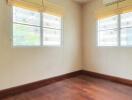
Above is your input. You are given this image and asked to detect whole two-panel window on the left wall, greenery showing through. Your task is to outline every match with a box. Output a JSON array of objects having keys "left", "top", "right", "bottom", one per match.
[{"left": 13, "top": 6, "right": 62, "bottom": 46}]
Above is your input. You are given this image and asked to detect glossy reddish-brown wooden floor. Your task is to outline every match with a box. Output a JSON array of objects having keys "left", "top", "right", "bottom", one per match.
[{"left": 3, "top": 76, "right": 132, "bottom": 100}]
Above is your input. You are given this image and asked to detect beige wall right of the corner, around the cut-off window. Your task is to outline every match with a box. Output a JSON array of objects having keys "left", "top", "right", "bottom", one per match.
[{"left": 83, "top": 0, "right": 132, "bottom": 79}]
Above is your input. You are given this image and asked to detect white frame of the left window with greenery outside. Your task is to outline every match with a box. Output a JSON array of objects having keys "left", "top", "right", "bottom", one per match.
[{"left": 10, "top": 6, "right": 64, "bottom": 48}]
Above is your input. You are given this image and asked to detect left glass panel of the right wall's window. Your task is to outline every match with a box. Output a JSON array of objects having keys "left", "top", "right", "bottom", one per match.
[{"left": 98, "top": 16, "right": 118, "bottom": 46}]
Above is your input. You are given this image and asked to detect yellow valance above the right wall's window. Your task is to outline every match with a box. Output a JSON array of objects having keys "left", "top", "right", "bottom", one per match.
[{"left": 96, "top": 0, "right": 132, "bottom": 19}]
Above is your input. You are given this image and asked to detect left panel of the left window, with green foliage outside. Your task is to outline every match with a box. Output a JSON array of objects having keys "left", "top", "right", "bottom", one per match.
[{"left": 13, "top": 7, "right": 40, "bottom": 46}]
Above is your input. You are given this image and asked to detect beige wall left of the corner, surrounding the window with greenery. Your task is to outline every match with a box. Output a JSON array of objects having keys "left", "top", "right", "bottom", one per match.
[{"left": 0, "top": 0, "right": 82, "bottom": 90}]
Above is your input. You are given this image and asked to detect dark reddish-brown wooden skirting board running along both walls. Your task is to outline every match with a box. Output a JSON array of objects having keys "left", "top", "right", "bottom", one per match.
[{"left": 0, "top": 70, "right": 132, "bottom": 100}]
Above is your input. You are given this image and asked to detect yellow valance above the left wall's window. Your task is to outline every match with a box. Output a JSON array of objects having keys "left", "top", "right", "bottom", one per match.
[{"left": 8, "top": 0, "right": 63, "bottom": 16}]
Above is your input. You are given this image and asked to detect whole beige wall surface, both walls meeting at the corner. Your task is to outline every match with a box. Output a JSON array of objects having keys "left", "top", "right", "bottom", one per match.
[{"left": 0, "top": 0, "right": 132, "bottom": 90}]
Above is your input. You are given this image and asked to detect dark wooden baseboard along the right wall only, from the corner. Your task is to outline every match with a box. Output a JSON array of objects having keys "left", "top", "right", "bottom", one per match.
[{"left": 81, "top": 70, "right": 132, "bottom": 86}]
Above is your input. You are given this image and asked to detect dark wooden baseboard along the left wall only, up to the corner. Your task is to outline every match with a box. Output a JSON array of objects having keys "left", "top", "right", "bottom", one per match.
[{"left": 0, "top": 71, "right": 82, "bottom": 100}]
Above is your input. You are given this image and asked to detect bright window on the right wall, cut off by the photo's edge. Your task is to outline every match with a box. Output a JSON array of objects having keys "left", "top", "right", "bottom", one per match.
[{"left": 98, "top": 12, "right": 132, "bottom": 46}]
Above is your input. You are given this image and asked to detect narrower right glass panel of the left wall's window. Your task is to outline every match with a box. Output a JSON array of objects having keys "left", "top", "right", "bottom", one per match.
[{"left": 43, "top": 13, "right": 62, "bottom": 46}]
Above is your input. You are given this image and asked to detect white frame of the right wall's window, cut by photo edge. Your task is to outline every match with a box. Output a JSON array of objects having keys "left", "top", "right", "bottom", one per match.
[{"left": 96, "top": 12, "right": 132, "bottom": 48}]
